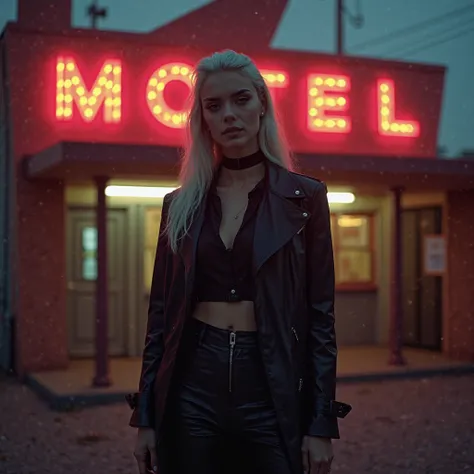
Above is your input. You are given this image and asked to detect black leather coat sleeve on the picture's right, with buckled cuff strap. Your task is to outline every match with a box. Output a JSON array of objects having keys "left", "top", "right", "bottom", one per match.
[{"left": 305, "top": 182, "right": 351, "bottom": 439}]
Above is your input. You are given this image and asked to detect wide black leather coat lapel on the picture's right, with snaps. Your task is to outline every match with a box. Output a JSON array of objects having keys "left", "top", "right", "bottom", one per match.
[{"left": 253, "top": 163, "right": 310, "bottom": 274}]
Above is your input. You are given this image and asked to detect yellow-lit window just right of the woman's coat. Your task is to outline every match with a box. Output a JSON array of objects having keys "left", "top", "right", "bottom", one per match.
[{"left": 331, "top": 214, "right": 375, "bottom": 290}]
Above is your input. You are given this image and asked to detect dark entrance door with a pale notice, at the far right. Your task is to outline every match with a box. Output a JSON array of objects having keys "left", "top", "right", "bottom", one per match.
[{"left": 402, "top": 207, "right": 443, "bottom": 350}]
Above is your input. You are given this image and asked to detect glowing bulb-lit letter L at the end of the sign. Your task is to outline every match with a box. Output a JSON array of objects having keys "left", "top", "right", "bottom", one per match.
[{"left": 377, "top": 79, "right": 420, "bottom": 137}]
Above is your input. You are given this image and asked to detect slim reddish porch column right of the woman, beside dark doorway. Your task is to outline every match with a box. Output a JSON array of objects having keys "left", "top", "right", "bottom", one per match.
[{"left": 388, "top": 187, "right": 406, "bottom": 365}]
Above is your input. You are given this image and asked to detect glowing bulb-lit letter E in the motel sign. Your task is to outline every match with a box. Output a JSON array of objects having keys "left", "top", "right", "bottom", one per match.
[{"left": 307, "top": 74, "right": 352, "bottom": 133}]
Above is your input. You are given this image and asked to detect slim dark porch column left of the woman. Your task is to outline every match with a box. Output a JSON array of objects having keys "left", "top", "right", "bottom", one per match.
[{"left": 92, "top": 176, "right": 111, "bottom": 387}]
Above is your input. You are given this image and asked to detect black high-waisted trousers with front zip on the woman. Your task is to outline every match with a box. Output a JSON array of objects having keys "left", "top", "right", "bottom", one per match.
[{"left": 168, "top": 320, "right": 290, "bottom": 474}]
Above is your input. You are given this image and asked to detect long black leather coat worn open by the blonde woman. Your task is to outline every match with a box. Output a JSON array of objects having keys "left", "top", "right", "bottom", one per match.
[{"left": 129, "top": 163, "right": 350, "bottom": 474}]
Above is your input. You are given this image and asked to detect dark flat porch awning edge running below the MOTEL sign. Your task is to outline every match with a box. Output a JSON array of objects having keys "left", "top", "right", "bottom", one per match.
[{"left": 24, "top": 142, "right": 474, "bottom": 191}]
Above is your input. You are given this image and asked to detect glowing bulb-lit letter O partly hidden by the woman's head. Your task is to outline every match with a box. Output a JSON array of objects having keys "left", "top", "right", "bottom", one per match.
[{"left": 146, "top": 63, "right": 192, "bottom": 128}]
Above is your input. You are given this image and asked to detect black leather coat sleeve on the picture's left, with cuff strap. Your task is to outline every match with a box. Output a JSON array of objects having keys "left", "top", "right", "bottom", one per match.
[{"left": 126, "top": 195, "right": 170, "bottom": 428}]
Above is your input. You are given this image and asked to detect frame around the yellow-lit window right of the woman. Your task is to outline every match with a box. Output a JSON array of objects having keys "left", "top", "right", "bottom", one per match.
[{"left": 331, "top": 210, "right": 378, "bottom": 292}]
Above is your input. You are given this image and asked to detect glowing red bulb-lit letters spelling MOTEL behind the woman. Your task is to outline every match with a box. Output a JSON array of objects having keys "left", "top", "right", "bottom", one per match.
[{"left": 56, "top": 57, "right": 420, "bottom": 138}]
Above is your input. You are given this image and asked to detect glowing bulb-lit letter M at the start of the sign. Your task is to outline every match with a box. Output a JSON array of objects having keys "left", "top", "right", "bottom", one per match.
[{"left": 56, "top": 57, "right": 122, "bottom": 123}]
